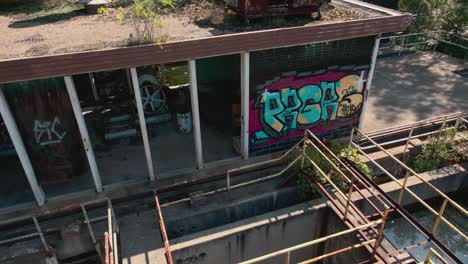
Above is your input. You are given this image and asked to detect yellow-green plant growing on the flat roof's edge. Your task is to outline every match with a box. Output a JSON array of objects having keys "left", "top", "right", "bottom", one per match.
[{"left": 119, "top": 0, "right": 175, "bottom": 45}]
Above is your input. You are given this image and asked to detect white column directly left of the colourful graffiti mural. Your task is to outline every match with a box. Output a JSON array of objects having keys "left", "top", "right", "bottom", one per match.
[{"left": 241, "top": 52, "right": 250, "bottom": 159}]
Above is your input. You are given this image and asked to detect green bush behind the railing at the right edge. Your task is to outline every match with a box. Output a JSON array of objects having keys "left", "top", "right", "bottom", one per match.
[{"left": 413, "top": 127, "right": 468, "bottom": 173}]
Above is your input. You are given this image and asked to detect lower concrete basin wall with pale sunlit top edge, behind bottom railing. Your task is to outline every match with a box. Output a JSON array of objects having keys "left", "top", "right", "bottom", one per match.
[{"left": 171, "top": 200, "right": 369, "bottom": 264}]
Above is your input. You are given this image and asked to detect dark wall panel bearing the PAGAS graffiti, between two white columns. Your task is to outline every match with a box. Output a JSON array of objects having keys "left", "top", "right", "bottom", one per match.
[{"left": 249, "top": 37, "right": 374, "bottom": 156}]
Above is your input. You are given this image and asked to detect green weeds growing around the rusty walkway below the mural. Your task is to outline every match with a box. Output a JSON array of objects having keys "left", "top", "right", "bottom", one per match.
[{"left": 292, "top": 141, "right": 373, "bottom": 199}]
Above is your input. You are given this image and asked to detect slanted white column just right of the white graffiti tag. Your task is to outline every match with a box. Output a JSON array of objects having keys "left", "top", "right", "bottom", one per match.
[{"left": 64, "top": 76, "right": 102, "bottom": 192}]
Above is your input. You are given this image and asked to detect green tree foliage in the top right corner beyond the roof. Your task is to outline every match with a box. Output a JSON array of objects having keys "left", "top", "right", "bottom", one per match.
[{"left": 398, "top": 0, "right": 468, "bottom": 35}]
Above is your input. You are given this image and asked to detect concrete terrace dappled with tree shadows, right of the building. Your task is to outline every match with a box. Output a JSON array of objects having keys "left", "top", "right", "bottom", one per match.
[{"left": 363, "top": 52, "right": 468, "bottom": 131}]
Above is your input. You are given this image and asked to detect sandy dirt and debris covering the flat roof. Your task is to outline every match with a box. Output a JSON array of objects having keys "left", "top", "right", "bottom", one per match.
[{"left": 0, "top": 0, "right": 384, "bottom": 59}]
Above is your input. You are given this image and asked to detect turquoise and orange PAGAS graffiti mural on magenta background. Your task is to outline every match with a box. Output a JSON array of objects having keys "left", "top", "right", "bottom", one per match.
[{"left": 249, "top": 70, "right": 367, "bottom": 144}]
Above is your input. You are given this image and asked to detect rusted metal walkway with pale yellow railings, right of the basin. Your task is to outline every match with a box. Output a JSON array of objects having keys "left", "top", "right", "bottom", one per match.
[{"left": 239, "top": 113, "right": 468, "bottom": 264}]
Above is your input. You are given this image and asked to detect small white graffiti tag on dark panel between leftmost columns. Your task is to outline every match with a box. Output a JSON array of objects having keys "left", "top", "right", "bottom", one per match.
[{"left": 33, "top": 117, "right": 67, "bottom": 146}]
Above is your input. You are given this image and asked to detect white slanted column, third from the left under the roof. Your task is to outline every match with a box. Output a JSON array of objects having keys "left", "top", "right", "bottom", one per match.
[{"left": 130, "top": 68, "right": 155, "bottom": 181}]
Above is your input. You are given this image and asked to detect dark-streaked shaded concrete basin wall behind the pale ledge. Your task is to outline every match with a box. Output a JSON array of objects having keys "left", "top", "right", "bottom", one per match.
[{"left": 162, "top": 181, "right": 301, "bottom": 239}]
